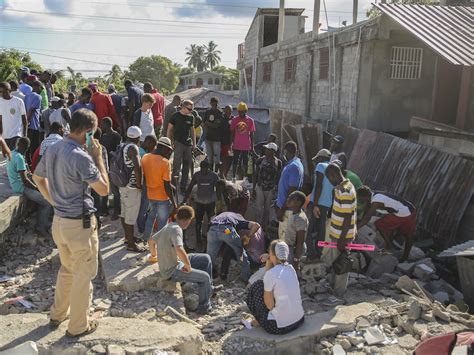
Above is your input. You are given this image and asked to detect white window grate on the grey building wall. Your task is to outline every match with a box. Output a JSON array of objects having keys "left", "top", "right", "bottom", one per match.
[{"left": 390, "top": 47, "right": 423, "bottom": 80}]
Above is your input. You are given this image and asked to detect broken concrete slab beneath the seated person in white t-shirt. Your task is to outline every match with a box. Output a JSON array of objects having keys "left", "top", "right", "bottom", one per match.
[{"left": 223, "top": 302, "right": 377, "bottom": 354}]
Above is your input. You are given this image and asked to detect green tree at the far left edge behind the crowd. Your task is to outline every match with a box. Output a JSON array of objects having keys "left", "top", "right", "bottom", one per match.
[{"left": 0, "top": 49, "right": 43, "bottom": 81}]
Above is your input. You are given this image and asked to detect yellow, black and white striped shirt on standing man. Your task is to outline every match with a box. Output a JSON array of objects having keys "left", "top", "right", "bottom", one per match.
[{"left": 329, "top": 179, "right": 357, "bottom": 239}]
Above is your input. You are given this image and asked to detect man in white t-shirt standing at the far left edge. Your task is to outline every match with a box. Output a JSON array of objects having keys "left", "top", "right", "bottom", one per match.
[{"left": 0, "top": 82, "right": 28, "bottom": 150}]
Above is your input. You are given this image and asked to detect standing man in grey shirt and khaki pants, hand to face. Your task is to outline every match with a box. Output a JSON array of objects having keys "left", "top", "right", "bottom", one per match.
[{"left": 33, "top": 109, "right": 109, "bottom": 337}]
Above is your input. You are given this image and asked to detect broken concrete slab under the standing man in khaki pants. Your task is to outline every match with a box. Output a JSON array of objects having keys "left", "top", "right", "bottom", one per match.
[{"left": 0, "top": 313, "right": 204, "bottom": 355}]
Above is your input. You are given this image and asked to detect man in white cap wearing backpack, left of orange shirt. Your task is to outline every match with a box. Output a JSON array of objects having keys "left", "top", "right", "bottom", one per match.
[{"left": 110, "top": 126, "right": 144, "bottom": 253}]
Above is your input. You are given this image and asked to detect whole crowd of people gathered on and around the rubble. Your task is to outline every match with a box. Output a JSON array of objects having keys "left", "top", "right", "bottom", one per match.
[{"left": 0, "top": 69, "right": 416, "bottom": 337}]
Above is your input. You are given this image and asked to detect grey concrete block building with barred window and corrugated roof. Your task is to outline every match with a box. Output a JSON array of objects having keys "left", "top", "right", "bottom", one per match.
[{"left": 237, "top": 4, "right": 474, "bottom": 135}]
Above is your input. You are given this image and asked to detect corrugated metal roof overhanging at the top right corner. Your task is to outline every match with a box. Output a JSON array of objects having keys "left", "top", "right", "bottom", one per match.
[{"left": 375, "top": 4, "right": 474, "bottom": 66}]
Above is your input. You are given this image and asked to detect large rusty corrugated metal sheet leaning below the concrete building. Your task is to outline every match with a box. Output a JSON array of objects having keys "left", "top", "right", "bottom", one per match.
[{"left": 340, "top": 128, "right": 474, "bottom": 248}]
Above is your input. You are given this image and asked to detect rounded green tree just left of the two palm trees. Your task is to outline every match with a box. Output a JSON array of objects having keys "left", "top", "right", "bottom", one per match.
[{"left": 125, "top": 55, "right": 180, "bottom": 95}]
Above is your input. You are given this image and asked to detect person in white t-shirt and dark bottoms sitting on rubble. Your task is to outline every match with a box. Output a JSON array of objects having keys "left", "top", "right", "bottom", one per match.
[{"left": 247, "top": 240, "right": 304, "bottom": 334}]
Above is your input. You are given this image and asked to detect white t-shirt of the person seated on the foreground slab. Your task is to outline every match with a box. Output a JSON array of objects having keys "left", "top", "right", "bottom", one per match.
[{"left": 263, "top": 264, "right": 304, "bottom": 328}]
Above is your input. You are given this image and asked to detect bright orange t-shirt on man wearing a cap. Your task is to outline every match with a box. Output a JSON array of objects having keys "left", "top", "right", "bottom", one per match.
[{"left": 142, "top": 154, "right": 171, "bottom": 201}]
